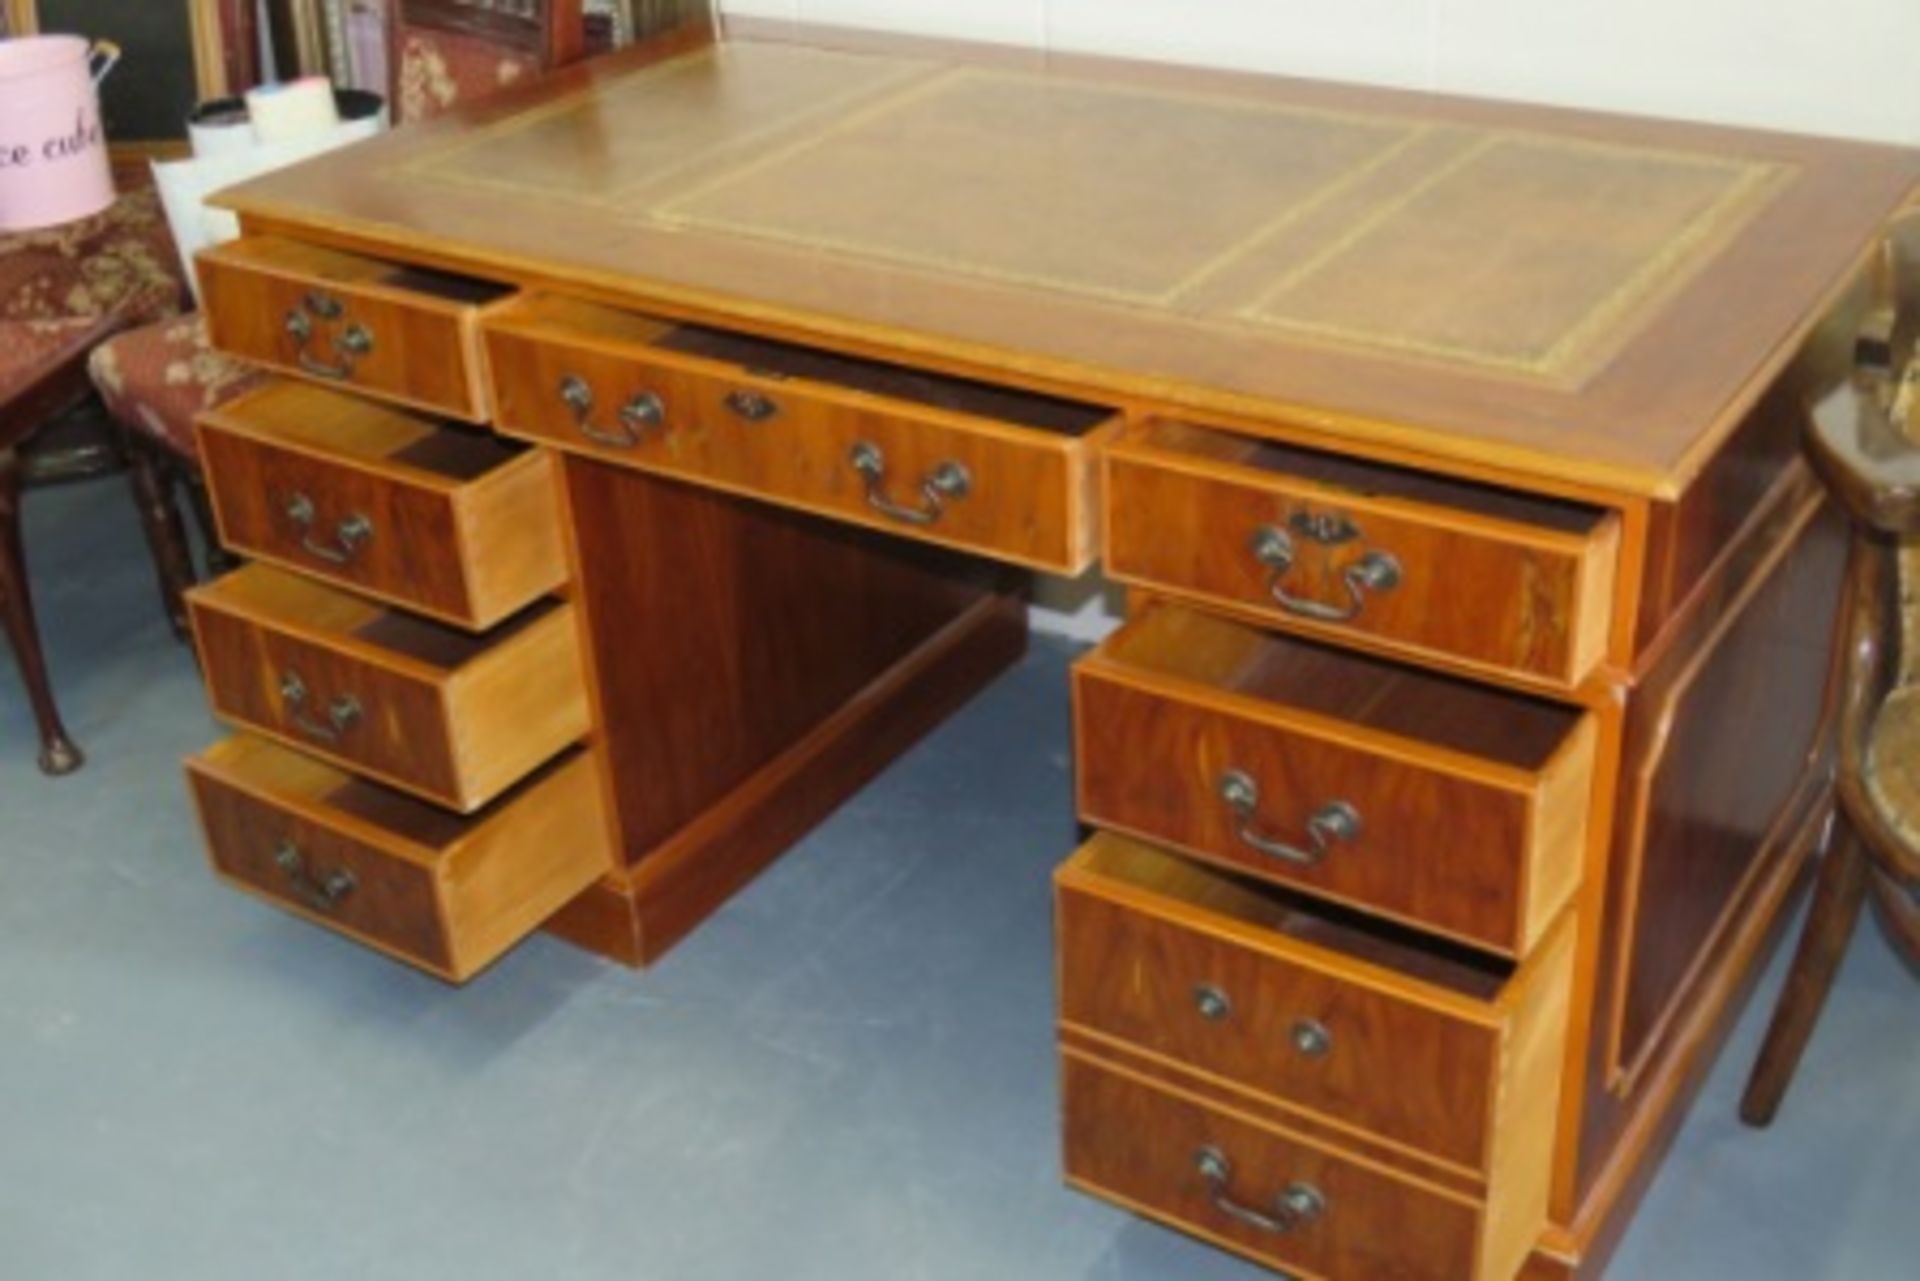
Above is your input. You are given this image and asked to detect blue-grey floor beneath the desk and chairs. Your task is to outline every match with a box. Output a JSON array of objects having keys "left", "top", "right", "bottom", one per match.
[{"left": 0, "top": 480, "right": 1920, "bottom": 1281}]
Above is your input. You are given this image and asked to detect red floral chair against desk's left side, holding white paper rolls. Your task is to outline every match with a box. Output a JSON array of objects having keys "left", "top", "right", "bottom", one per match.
[{"left": 90, "top": 0, "right": 614, "bottom": 638}]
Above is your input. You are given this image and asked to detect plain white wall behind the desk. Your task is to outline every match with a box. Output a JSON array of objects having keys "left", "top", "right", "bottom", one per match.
[{"left": 720, "top": 0, "right": 1920, "bottom": 638}]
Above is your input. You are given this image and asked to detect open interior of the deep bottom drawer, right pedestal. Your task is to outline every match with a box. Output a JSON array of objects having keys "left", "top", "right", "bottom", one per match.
[{"left": 1069, "top": 832, "right": 1515, "bottom": 1004}]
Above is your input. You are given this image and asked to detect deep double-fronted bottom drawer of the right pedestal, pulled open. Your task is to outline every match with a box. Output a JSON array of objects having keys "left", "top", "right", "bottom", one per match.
[{"left": 1054, "top": 834, "right": 1572, "bottom": 1281}]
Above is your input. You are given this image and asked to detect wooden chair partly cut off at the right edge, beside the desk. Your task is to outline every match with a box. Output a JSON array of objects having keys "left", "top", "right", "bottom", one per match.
[{"left": 1740, "top": 213, "right": 1920, "bottom": 1125}]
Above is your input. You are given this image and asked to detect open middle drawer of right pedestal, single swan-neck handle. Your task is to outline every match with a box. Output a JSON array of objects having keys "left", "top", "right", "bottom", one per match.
[{"left": 1073, "top": 603, "right": 1596, "bottom": 956}]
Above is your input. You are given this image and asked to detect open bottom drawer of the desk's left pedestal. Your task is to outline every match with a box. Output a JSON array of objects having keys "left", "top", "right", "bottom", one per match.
[{"left": 186, "top": 736, "right": 612, "bottom": 981}]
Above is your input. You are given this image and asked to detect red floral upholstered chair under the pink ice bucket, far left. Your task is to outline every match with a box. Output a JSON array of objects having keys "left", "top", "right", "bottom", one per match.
[{"left": 0, "top": 190, "right": 184, "bottom": 774}]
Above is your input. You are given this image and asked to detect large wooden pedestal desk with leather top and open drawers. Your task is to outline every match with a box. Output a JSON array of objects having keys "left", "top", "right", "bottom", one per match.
[{"left": 172, "top": 15, "right": 1920, "bottom": 1281}]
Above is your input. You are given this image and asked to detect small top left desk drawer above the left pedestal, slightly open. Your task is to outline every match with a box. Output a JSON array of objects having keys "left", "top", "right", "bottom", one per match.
[{"left": 198, "top": 236, "right": 513, "bottom": 423}]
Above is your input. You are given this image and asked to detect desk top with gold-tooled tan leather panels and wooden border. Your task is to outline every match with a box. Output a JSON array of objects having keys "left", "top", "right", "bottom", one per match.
[{"left": 210, "top": 27, "right": 1920, "bottom": 494}]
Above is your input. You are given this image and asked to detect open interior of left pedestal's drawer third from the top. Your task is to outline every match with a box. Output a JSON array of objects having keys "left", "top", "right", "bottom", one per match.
[{"left": 196, "top": 565, "right": 559, "bottom": 674}]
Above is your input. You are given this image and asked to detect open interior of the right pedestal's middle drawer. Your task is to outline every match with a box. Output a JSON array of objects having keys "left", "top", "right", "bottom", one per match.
[{"left": 1098, "top": 605, "right": 1582, "bottom": 774}]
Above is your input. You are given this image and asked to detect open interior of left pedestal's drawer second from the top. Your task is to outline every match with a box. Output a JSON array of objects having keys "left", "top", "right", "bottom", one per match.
[{"left": 217, "top": 382, "right": 526, "bottom": 484}]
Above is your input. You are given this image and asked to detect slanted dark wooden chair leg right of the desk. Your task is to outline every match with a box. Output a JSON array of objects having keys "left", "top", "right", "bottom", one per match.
[{"left": 1740, "top": 814, "right": 1868, "bottom": 1125}]
